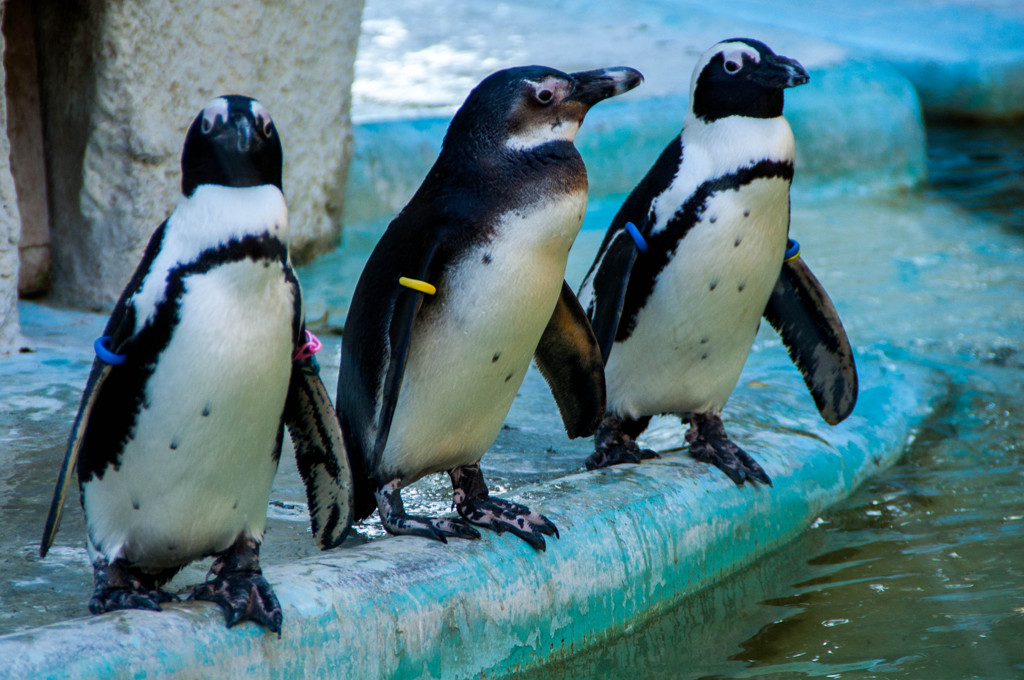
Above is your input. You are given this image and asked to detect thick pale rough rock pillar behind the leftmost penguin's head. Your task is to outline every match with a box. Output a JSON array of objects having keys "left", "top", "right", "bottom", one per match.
[{"left": 38, "top": 0, "right": 362, "bottom": 307}]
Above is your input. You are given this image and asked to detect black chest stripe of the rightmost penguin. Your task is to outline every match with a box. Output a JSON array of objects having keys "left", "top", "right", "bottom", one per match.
[{"left": 615, "top": 160, "right": 793, "bottom": 342}]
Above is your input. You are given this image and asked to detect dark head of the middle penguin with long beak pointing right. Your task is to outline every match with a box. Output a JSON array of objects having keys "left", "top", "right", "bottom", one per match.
[{"left": 444, "top": 66, "right": 643, "bottom": 150}]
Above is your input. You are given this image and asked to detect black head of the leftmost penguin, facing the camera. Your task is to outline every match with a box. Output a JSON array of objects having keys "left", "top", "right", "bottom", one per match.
[{"left": 181, "top": 94, "right": 282, "bottom": 196}]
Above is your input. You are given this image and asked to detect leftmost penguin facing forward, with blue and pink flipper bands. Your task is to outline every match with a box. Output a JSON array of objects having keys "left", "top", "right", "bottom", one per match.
[{"left": 40, "top": 95, "right": 352, "bottom": 636}]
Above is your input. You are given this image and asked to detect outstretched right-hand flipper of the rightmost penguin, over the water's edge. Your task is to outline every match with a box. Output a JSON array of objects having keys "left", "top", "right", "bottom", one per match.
[{"left": 764, "top": 258, "right": 857, "bottom": 425}]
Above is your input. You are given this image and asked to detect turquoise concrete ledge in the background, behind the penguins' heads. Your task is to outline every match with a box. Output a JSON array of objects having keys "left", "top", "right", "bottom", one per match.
[{"left": 343, "top": 60, "right": 927, "bottom": 229}]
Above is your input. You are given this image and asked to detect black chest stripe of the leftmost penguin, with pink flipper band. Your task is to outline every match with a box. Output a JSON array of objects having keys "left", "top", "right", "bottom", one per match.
[{"left": 78, "top": 233, "right": 300, "bottom": 485}]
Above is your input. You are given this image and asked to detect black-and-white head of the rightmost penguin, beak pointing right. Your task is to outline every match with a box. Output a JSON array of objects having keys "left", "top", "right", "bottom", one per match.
[{"left": 690, "top": 38, "right": 810, "bottom": 123}]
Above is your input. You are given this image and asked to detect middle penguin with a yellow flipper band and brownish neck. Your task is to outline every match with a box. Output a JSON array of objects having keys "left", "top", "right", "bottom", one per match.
[{"left": 336, "top": 66, "right": 642, "bottom": 550}]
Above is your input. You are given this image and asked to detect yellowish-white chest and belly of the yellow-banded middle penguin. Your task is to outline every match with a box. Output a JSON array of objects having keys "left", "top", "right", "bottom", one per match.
[{"left": 381, "top": 193, "right": 587, "bottom": 483}]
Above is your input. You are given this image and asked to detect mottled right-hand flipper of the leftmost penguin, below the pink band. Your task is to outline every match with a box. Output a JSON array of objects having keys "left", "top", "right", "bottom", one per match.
[{"left": 285, "top": 357, "right": 352, "bottom": 550}]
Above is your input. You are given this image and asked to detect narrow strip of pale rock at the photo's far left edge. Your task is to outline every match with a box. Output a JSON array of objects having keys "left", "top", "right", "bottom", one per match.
[{"left": 0, "top": 4, "right": 20, "bottom": 354}]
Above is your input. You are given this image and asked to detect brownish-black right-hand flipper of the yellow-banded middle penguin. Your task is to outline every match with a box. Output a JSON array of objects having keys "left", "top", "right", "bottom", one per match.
[{"left": 534, "top": 282, "right": 605, "bottom": 438}]
